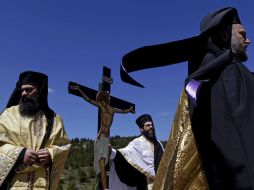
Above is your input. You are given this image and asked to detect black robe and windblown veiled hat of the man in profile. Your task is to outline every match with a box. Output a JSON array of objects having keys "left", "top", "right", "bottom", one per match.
[{"left": 121, "top": 7, "right": 254, "bottom": 190}]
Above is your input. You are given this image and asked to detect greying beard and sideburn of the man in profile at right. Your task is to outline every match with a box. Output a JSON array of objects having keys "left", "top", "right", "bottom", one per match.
[{"left": 231, "top": 35, "right": 248, "bottom": 62}]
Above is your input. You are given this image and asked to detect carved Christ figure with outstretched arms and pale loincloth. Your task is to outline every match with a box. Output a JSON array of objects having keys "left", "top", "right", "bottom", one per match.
[{"left": 69, "top": 84, "right": 135, "bottom": 189}]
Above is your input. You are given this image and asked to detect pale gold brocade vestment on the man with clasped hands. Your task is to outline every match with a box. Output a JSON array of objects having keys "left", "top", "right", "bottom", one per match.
[{"left": 0, "top": 106, "right": 71, "bottom": 190}]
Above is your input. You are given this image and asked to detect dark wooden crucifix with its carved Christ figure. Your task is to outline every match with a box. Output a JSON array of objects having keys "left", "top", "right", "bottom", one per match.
[{"left": 68, "top": 67, "right": 135, "bottom": 190}]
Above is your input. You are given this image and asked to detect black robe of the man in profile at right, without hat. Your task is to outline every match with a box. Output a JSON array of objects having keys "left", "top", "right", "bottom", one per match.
[{"left": 188, "top": 42, "right": 254, "bottom": 190}]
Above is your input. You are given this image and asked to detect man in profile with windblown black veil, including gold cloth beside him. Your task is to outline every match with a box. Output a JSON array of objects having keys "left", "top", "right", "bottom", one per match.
[{"left": 121, "top": 7, "right": 254, "bottom": 190}]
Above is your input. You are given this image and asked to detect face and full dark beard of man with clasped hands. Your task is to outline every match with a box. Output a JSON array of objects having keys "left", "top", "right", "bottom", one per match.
[{"left": 19, "top": 85, "right": 40, "bottom": 116}]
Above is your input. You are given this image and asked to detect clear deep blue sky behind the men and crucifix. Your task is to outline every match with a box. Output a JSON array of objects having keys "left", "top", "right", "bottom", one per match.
[{"left": 0, "top": 0, "right": 254, "bottom": 140}]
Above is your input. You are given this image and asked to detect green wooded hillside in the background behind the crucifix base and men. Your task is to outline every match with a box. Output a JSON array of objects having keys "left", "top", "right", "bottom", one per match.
[{"left": 58, "top": 136, "right": 166, "bottom": 190}]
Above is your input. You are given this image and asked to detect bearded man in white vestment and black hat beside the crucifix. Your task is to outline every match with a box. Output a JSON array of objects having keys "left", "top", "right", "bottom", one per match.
[{"left": 109, "top": 114, "right": 164, "bottom": 190}]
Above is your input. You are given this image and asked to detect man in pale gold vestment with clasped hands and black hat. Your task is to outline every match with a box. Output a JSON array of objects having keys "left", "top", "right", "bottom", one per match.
[{"left": 0, "top": 71, "right": 71, "bottom": 190}]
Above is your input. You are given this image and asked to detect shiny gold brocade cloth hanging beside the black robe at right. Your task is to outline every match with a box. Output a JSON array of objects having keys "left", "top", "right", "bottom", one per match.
[{"left": 153, "top": 91, "right": 209, "bottom": 190}]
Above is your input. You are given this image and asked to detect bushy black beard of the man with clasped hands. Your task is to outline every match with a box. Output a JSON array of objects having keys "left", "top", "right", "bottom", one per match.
[{"left": 19, "top": 94, "right": 41, "bottom": 117}]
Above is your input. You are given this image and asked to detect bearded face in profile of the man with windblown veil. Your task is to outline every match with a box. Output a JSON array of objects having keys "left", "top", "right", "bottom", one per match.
[{"left": 231, "top": 24, "right": 250, "bottom": 62}]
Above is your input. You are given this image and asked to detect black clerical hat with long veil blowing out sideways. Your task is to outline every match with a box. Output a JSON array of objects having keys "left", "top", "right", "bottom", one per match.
[{"left": 120, "top": 7, "right": 240, "bottom": 87}]
